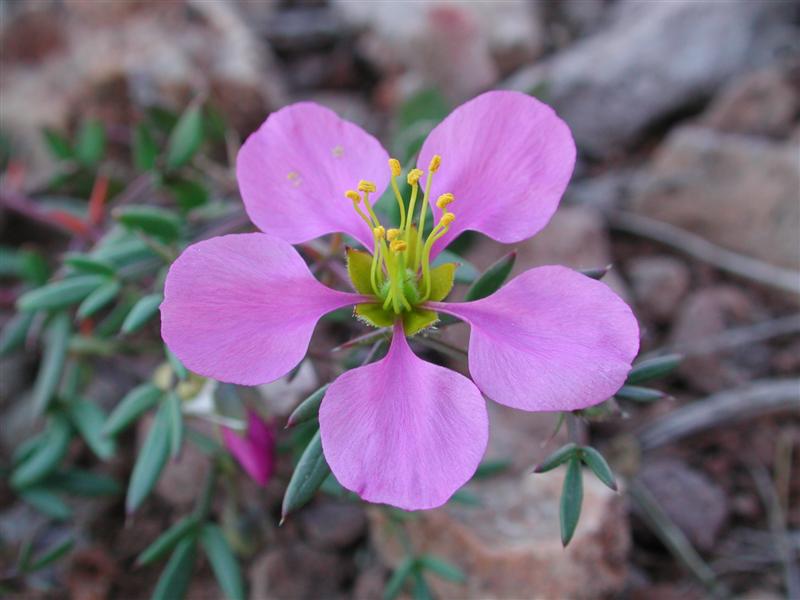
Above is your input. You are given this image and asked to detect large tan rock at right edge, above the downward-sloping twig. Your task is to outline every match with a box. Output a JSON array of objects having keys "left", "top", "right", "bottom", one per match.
[{"left": 629, "top": 127, "right": 800, "bottom": 270}]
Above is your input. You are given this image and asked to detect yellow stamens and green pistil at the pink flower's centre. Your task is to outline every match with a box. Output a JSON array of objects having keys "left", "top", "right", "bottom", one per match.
[{"left": 345, "top": 154, "right": 455, "bottom": 315}]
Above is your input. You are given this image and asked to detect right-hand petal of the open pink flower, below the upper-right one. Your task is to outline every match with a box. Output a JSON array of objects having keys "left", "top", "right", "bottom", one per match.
[{"left": 430, "top": 266, "right": 639, "bottom": 411}]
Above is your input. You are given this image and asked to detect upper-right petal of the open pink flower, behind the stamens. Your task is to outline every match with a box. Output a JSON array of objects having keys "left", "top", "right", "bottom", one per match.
[{"left": 417, "top": 91, "right": 575, "bottom": 254}]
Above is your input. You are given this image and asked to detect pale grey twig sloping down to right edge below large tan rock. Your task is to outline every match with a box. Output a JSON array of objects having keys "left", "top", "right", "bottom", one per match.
[{"left": 605, "top": 210, "right": 800, "bottom": 295}]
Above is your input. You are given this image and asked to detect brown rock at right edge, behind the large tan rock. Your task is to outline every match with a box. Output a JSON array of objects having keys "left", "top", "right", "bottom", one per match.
[{"left": 700, "top": 62, "right": 800, "bottom": 138}]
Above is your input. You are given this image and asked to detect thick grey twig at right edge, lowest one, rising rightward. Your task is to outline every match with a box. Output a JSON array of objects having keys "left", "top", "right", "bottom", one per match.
[{"left": 637, "top": 378, "right": 800, "bottom": 450}]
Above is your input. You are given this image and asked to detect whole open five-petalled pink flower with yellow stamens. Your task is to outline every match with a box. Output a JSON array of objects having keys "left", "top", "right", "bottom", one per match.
[{"left": 161, "top": 92, "right": 639, "bottom": 510}]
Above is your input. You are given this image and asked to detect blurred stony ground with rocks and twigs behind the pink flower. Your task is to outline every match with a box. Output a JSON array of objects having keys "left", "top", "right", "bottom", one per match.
[{"left": 0, "top": 0, "right": 800, "bottom": 600}]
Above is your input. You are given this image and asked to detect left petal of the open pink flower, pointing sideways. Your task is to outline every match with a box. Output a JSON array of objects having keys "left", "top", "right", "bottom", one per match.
[{"left": 161, "top": 233, "right": 361, "bottom": 385}]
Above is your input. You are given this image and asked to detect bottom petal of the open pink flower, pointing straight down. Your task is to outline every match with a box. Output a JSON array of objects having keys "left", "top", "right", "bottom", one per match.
[{"left": 319, "top": 326, "right": 489, "bottom": 510}]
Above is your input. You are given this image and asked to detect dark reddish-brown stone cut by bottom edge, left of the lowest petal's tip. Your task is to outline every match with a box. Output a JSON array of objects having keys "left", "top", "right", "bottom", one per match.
[{"left": 249, "top": 543, "right": 353, "bottom": 600}]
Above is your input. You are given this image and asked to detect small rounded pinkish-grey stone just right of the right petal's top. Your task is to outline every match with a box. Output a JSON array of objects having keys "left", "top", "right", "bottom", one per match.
[{"left": 627, "top": 256, "right": 690, "bottom": 322}]
